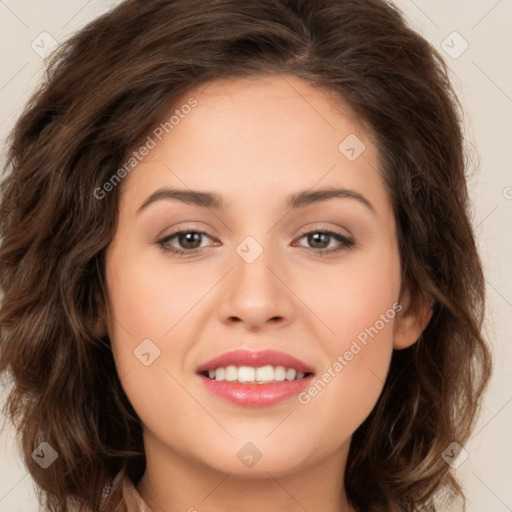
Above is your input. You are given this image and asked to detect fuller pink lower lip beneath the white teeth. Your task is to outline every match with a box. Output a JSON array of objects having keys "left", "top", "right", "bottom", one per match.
[{"left": 200, "top": 375, "right": 313, "bottom": 407}]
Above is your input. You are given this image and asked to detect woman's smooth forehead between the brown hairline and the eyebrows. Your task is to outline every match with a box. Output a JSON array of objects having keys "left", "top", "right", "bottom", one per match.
[{"left": 116, "top": 75, "right": 387, "bottom": 218}]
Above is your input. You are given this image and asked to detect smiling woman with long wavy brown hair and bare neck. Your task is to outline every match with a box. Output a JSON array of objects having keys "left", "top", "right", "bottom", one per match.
[{"left": 0, "top": 0, "right": 491, "bottom": 512}]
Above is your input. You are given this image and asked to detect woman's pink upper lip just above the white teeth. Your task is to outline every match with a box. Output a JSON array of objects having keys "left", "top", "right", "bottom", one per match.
[{"left": 197, "top": 349, "right": 314, "bottom": 373}]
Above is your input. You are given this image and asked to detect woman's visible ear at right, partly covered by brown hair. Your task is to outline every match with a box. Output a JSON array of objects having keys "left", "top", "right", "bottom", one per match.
[{"left": 393, "top": 288, "right": 435, "bottom": 350}]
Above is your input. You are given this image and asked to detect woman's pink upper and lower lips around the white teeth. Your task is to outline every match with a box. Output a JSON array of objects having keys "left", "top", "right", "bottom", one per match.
[{"left": 197, "top": 350, "right": 314, "bottom": 407}]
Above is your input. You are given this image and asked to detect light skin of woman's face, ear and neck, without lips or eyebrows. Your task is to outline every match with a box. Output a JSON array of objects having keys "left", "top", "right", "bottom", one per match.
[{"left": 104, "top": 76, "right": 425, "bottom": 512}]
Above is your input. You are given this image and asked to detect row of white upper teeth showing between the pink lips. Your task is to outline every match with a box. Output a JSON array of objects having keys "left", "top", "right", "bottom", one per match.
[{"left": 203, "top": 365, "right": 305, "bottom": 383}]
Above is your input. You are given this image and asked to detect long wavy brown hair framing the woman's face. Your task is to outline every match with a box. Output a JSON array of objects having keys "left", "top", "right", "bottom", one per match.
[{"left": 0, "top": 0, "right": 492, "bottom": 512}]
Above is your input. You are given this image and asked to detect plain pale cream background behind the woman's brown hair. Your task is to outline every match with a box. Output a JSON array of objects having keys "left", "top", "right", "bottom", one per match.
[{"left": 0, "top": 0, "right": 512, "bottom": 512}]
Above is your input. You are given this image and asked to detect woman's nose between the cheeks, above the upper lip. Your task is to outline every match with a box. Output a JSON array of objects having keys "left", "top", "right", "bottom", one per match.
[{"left": 219, "top": 243, "right": 296, "bottom": 332}]
